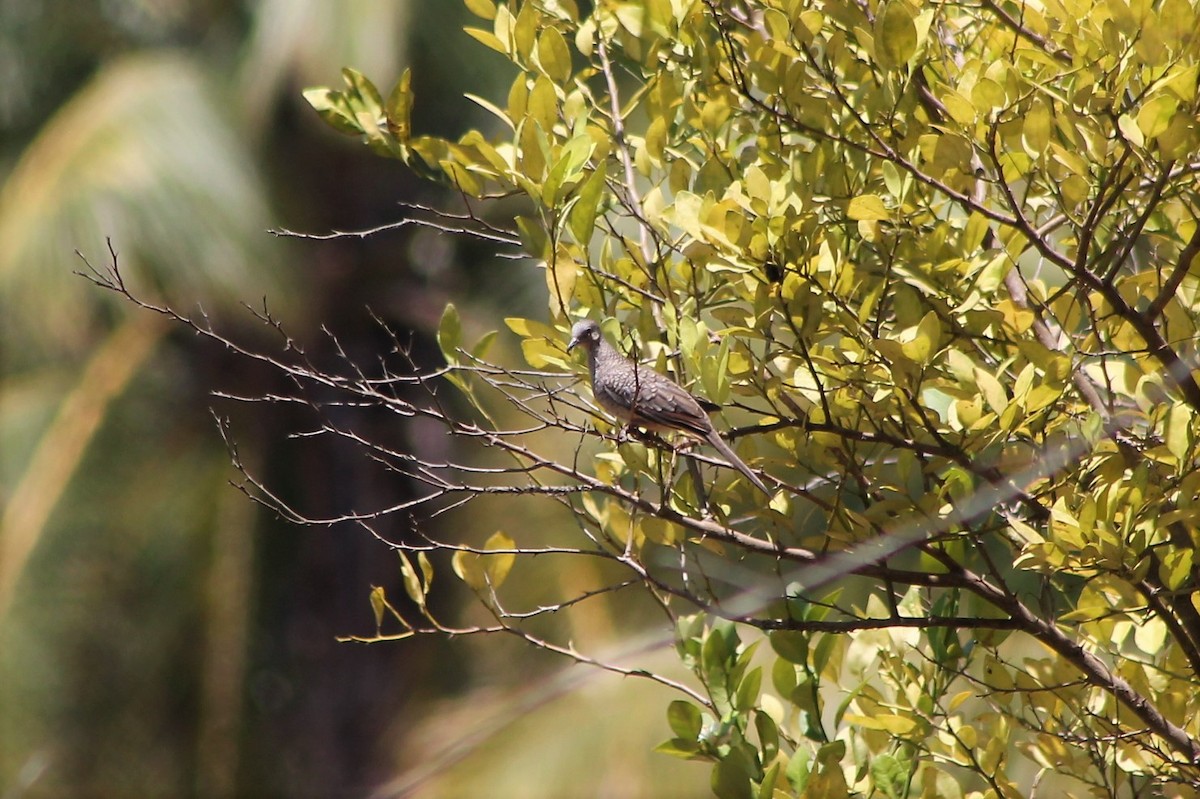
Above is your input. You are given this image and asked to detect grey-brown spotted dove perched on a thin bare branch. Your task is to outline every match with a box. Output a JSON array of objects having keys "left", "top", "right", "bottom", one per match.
[{"left": 566, "top": 319, "right": 770, "bottom": 497}]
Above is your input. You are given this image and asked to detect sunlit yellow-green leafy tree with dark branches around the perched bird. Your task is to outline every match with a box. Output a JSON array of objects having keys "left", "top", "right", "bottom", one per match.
[{"left": 292, "top": 0, "right": 1200, "bottom": 797}]
